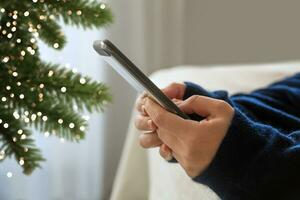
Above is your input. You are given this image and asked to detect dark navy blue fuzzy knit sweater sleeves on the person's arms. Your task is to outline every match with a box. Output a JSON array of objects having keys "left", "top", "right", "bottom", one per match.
[{"left": 184, "top": 73, "right": 300, "bottom": 200}]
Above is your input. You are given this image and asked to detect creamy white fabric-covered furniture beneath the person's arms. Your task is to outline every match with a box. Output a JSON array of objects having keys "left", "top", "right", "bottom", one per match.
[{"left": 111, "top": 62, "right": 300, "bottom": 200}]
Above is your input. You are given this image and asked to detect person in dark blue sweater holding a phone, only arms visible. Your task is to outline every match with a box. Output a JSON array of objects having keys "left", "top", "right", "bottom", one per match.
[{"left": 135, "top": 73, "right": 300, "bottom": 200}]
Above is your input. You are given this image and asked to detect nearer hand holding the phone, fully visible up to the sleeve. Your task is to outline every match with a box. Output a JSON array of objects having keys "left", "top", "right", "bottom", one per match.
[{"left": 141, "top": 95, "right": 234, "bottom": 177}]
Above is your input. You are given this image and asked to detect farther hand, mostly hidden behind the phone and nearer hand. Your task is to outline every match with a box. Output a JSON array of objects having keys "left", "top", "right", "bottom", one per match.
[{"left": 135, "top": 83, "right": 186, "bottom": 160}]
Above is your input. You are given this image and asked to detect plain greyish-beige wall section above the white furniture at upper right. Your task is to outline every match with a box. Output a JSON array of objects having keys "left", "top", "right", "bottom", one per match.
[{"left": 185, "top": 0, "right": 300, "bottom": 64}]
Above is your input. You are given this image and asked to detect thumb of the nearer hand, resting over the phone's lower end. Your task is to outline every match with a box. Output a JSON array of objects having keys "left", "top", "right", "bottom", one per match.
[{"left": 178, "top": 95, "right": 217, "bottom": 118}]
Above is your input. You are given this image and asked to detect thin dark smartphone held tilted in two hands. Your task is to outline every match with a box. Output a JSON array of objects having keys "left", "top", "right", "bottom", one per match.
[{"left": 93, "top": 40, "right": 190, "bottom": 119}]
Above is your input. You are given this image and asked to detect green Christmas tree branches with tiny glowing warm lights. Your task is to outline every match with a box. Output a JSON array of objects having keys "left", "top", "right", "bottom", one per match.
[{"left": 0, "top": 0, "right": 112, "bottom": 174}]
